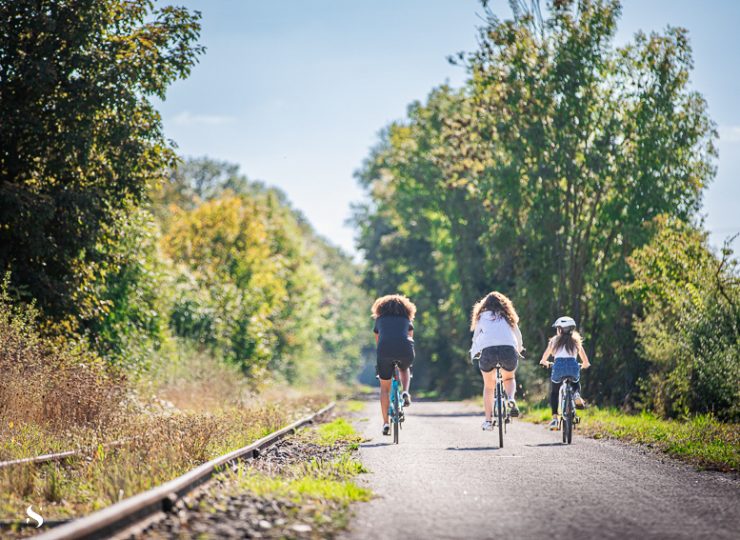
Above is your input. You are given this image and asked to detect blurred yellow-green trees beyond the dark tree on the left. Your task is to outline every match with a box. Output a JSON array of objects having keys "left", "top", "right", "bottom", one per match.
[{"left": 160, "top": 158, "right": 370, "bottom": 381}]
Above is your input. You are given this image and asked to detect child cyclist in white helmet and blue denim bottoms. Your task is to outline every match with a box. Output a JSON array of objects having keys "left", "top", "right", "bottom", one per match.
[{"left": 540, "top": 317, "right": 591, "bottom": 430}]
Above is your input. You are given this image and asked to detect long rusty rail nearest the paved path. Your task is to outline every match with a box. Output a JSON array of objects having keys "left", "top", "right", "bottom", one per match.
[{"left": 16, "top": 402, "right": 335, "bottom": 540}]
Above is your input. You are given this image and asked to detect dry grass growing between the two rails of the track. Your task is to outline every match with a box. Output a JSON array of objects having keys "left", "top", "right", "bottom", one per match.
[{"left": 0, "top": 390, "right": 330, "bottom": 519}]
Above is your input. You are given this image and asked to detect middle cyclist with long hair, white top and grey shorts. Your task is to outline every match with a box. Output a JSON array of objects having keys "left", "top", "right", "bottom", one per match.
[{"left": 470, "top": 291, "right": 524, "bottom": 431}]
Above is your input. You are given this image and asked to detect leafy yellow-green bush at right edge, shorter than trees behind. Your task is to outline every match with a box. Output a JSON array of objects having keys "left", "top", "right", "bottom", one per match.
[{"left": 618, "top": 216, "right": 740, "bottom": 421}]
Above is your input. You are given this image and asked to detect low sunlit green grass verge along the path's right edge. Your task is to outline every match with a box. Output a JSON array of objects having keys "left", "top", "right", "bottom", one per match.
[{"left": 522, "top": 406, "right": 740, "bottom": 472}]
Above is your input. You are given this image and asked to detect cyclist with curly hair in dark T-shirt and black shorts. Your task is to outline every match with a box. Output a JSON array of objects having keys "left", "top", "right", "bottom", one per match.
[{"left": 372, "top": 294, "right": 416, "bottom": 435}]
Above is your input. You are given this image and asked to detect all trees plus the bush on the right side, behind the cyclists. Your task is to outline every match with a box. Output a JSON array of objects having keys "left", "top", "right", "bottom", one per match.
[{"left": 355, "top": 0, "right": 740, "bottom": 425}]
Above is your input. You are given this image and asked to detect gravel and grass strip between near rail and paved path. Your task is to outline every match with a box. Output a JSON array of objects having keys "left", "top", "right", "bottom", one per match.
[{"left": 139, "top": 416, "right": 371, "bottom": 539}]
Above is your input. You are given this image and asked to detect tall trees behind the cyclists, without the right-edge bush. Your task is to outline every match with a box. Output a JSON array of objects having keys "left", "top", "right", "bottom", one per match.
[{"left": 356, "top": 0, "right": 716, "bottom": 403}]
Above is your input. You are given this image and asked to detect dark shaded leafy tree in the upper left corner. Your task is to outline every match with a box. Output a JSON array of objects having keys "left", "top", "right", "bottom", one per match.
[{"left": 0, "top": 0, "right": 202, "bottom": 319}]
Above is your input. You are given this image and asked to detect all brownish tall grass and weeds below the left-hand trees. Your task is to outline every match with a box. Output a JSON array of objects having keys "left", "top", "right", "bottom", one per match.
[{"left": 0, "top": 289, "right": 329, "bottom": 520}]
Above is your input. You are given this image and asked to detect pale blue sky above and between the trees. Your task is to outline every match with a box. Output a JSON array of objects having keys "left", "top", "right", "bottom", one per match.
[{"left": 160, "top": 0, "right": 740, "bottom": 255}]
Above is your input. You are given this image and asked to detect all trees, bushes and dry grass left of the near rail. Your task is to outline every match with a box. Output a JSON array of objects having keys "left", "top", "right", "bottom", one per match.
[{"left": 0, "top": 0, "right": 368, "bottom": 519}]
